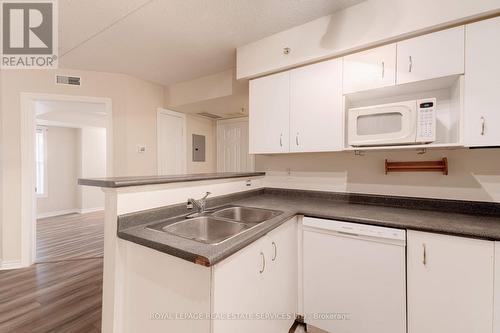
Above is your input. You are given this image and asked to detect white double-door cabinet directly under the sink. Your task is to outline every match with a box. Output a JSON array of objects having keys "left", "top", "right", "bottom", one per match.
[{"left": 212, "top": 218, "right": 298, "bottom": 333}]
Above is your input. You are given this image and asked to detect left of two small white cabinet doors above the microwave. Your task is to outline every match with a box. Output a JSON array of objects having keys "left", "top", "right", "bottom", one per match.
[{"left": 343, "top": 44, "right": 396, "bottom": 94}]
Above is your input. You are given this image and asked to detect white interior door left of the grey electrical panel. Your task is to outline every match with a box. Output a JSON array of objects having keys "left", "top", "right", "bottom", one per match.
[{"left": 157, "top": 109, "right": 186, "bottom": 175}]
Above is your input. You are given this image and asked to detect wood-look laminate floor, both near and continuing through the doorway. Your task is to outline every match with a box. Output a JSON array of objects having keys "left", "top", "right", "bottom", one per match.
[{"left": 0, "top": 212, "right": 104, "bottom": 333}]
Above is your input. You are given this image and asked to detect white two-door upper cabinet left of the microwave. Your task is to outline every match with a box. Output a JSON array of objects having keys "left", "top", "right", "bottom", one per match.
[{"left": 249, "top": 59, "right": 343, "bottom": 154}]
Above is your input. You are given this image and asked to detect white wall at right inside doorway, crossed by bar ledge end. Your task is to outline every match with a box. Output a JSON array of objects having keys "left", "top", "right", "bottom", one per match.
[{"left": 78, "top": 127, "right": 106, "bottom": 213}]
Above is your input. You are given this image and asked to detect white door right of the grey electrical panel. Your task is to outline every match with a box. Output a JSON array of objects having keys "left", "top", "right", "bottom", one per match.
[{"left": 217, "top": 118, "right": 254, "bottom": 172}]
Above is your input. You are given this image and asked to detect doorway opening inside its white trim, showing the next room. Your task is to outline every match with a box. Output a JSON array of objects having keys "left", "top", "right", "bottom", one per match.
[{"left": 35, "top": 100, "right": 106, "bottom": 263}]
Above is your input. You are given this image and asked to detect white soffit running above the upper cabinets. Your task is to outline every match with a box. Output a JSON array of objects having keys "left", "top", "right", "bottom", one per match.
[{"left": 237, "top": 0, "right": 500, "bottom": 79}]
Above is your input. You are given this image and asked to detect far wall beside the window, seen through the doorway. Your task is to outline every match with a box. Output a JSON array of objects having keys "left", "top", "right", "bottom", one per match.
[{"left": 37, "top": 127, "right": 79, "bottom": 216}]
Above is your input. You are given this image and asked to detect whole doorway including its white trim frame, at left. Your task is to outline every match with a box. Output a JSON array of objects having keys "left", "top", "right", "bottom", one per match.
[{"left": 21, "top": 93, "right": 113, "bottom": 266}]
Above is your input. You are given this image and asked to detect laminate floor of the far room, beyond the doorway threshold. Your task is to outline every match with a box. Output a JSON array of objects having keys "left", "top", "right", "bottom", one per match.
[{"left": 36, "top": 212, "right": 104, "bottom": 262}]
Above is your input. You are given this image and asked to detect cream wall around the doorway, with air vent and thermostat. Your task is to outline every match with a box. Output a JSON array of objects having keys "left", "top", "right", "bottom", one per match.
[{"left": 0, "top": 69, "right": 164, "bottom": 261}]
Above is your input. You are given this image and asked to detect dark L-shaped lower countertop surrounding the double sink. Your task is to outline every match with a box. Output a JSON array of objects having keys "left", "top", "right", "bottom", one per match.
[{"left": 118, "top": 188, "right": 500, "bottom": 266}]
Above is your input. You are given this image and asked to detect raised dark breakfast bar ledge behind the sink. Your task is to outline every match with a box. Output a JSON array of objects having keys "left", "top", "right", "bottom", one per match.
[{"left": 78, "top": 172, "right": 266, "bottom": 188}]
